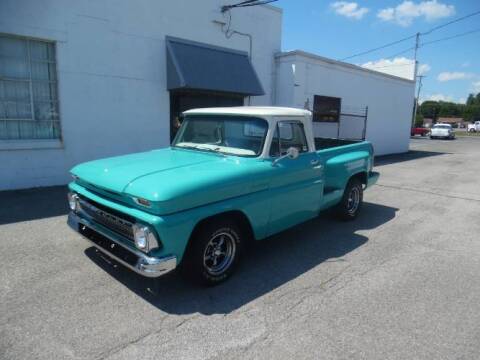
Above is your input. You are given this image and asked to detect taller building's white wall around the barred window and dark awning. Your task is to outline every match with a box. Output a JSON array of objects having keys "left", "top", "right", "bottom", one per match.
[{"left": 0, "top": 0, "right": 282, "bottom": 190}]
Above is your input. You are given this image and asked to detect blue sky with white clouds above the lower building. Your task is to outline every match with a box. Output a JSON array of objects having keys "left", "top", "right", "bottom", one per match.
[{"left": 273, "top": 0, "right": 480, "bottom": 103}]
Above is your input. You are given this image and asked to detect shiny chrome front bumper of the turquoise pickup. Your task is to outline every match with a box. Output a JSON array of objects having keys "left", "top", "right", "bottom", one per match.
[{"left": 67, "top": 212, "right": 177, "bottom": 277}]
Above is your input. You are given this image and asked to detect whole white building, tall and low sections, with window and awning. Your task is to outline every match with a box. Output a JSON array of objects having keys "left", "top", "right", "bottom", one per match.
[{"left": 0, "top": 0, "right": 414, "bottom": 190}]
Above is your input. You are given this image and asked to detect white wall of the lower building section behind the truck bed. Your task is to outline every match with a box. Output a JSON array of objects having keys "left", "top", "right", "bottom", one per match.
[{"left": 275, "top": 52, "right": 415, "bottom": 155}]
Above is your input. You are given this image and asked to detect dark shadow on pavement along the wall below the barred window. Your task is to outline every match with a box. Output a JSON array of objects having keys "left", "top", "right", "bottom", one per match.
[{"left": 0, "top": 186, "right": 68, "bottom": 225}]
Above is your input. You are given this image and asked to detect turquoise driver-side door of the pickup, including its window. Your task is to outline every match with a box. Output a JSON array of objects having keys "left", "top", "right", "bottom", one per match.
[{"left": 268, "top": 121, "right": 323, "bottom": 235}]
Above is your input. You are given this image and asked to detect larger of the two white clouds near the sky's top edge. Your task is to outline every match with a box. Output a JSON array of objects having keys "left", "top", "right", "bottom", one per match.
[{"left": 377, "top": 0, "right": 455, "bottom": 26}]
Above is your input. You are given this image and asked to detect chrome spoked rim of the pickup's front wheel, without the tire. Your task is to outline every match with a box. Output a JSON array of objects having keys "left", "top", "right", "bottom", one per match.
[{"left": 203, "top": 232, "right": 236, "bottom": 275}]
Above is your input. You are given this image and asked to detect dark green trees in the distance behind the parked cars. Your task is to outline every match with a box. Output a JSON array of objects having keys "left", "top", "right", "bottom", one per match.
[{"left": 418, "top": 93, "right": 480, "bottom": 123}]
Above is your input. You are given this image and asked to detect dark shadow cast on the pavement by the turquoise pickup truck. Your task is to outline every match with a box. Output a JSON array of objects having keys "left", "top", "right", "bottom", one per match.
[{"left": 85, "top": 203, "right": 398, "bottom": 314}]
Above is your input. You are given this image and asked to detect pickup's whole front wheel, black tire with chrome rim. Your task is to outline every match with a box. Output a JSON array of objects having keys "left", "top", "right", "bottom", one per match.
[{"left": 181, "top": 219, "right": 245, "bottom": 286}]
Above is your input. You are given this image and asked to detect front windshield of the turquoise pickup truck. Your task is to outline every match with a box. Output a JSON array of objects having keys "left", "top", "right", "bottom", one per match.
[{"left": 172, "top": 115, "right": 268, "bottom": 156}]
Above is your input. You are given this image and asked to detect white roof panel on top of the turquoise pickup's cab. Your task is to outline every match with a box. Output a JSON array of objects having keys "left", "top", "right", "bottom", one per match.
[{"left": 184, "top": 106, "right": 312, "bottom": 117}]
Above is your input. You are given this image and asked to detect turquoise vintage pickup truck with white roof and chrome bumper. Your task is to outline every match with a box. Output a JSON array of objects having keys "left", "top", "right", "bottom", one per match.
[{"left": 68, "top": 107, "right": 379, "bottom": 285}]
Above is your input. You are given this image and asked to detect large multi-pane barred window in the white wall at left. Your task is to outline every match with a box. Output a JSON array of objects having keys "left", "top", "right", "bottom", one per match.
[{"left": 0, "top": 34, "right": 60, "bottom": 140}]
